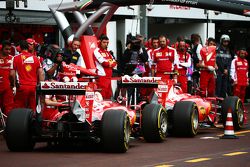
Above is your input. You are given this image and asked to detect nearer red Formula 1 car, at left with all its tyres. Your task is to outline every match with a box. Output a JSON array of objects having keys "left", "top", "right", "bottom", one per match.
[{"left": 6, "top": 66, "right": 167, "bottom": 152}]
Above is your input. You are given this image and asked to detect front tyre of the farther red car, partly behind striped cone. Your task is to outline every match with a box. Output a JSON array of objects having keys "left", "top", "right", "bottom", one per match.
[{"left": 221, "top": 96, "right": 244, "bottom": 130}]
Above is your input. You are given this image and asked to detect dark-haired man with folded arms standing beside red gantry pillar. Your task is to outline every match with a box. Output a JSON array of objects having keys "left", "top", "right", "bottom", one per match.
[{"left": 94, "top": 35, "right": 117, "bottom": 99}]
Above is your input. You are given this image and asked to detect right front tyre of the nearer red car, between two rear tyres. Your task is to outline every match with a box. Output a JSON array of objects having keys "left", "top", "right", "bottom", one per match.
[{"left": 142, "top": 104, "right": 168, "bottom": 142}]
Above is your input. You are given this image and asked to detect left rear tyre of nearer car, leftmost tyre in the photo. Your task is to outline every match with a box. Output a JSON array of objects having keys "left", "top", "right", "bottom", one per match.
[{"left": 5, "top": 108, "right": 35, "bottom": 151}]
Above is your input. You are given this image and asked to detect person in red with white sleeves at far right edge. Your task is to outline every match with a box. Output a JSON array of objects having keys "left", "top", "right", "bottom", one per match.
[{"left": 230, "top": 48, "right": 249, "bottom": 103}]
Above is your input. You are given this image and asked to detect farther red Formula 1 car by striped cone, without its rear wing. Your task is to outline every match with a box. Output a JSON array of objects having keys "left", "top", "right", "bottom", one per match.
[{"left": 155, "top": 73, "right": 247, "bottom": 136}]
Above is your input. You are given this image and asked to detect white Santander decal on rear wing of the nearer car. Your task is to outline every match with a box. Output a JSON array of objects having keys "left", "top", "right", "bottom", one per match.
[{"left": 41, "top": 82, "right": 88, "bottom": 90}]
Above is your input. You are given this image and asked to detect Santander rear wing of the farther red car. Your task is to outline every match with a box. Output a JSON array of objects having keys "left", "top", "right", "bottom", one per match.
[{"left": 119, "top": 75, "right": 161, "bottom": 88}]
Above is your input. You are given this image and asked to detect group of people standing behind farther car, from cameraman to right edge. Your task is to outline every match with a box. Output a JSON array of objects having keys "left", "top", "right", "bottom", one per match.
[{"left": 119, "top": 34, "right": 249, "bottom": 102}]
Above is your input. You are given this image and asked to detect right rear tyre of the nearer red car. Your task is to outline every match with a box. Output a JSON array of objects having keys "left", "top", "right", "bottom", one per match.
[{"left": 101, "top": 110, "right": 130, "bottom": 153}]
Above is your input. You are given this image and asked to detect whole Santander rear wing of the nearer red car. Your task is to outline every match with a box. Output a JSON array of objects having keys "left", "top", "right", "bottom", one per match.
[{"left": 36, "top": 81, "right": 88, "bottom": 95}]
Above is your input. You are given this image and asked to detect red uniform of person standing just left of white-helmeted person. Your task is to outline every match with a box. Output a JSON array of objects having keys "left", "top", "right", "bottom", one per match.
[{"left": 200, "top": 46, "right": 216, "bottom": 97}]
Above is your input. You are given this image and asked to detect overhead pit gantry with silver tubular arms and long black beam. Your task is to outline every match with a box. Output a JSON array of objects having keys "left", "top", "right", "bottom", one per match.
[{"left": 49, "top": 0, "right": 250, "bottom": 42}]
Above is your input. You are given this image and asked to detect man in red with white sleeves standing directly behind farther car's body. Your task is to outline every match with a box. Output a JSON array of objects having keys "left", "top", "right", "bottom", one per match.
[{"left": 177, "top": 40, "right": 191, "bottom": 93}]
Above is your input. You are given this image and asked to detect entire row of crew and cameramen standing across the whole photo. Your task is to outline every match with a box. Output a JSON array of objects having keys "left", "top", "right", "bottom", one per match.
[{"left": 0, "top": 34, "right": 249, "bottom": 114}]
